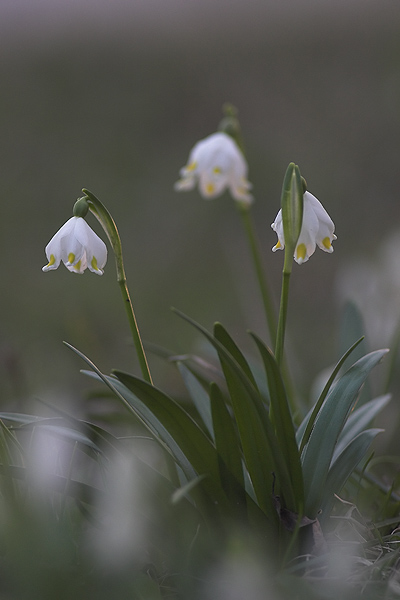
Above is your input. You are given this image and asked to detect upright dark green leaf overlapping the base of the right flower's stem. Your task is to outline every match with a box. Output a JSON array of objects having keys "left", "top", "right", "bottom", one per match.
[{"left": 250, "top": 333, "right": 304, "bottom": 511}]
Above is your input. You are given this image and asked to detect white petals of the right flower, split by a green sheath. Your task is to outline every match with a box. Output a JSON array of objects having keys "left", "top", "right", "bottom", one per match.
[{"left": 271, "top": 192, "right": 336, "bottom": 265}]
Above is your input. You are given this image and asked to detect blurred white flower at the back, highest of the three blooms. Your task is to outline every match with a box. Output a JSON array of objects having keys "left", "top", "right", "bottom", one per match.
[{"left": 175, "top": 132, "right": 253, "bottom": 204}]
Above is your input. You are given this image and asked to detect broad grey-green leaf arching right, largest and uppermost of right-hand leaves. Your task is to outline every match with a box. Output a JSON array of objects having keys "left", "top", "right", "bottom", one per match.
[{"left": 302, "top": 350, "right": 387, "bottom": 518}]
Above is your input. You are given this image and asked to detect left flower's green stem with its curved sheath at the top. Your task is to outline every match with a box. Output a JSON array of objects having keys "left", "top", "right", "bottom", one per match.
[{"left": 82, "top": 189, "right": 153, "bottom": 384}]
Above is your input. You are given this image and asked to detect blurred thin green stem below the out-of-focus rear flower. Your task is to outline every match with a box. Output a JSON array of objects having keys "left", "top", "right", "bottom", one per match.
[{"left": 237, "top": 202, "right": 276, "bottom": 346}]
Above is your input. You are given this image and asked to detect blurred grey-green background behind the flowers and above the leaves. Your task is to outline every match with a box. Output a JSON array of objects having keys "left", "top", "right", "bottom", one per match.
[{"left": 0, "top": 0, "right": 400, "bottom": 406}]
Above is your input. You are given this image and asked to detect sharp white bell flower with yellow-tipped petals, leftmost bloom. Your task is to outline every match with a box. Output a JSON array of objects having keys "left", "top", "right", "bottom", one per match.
[{"left": 43, "top": 217, "right": 107, "bottom": 275}]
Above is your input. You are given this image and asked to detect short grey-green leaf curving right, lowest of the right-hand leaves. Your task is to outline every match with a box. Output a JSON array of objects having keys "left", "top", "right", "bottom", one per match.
[{"left": 322, "top": 429, "right": 383, "bottom": 518}]
